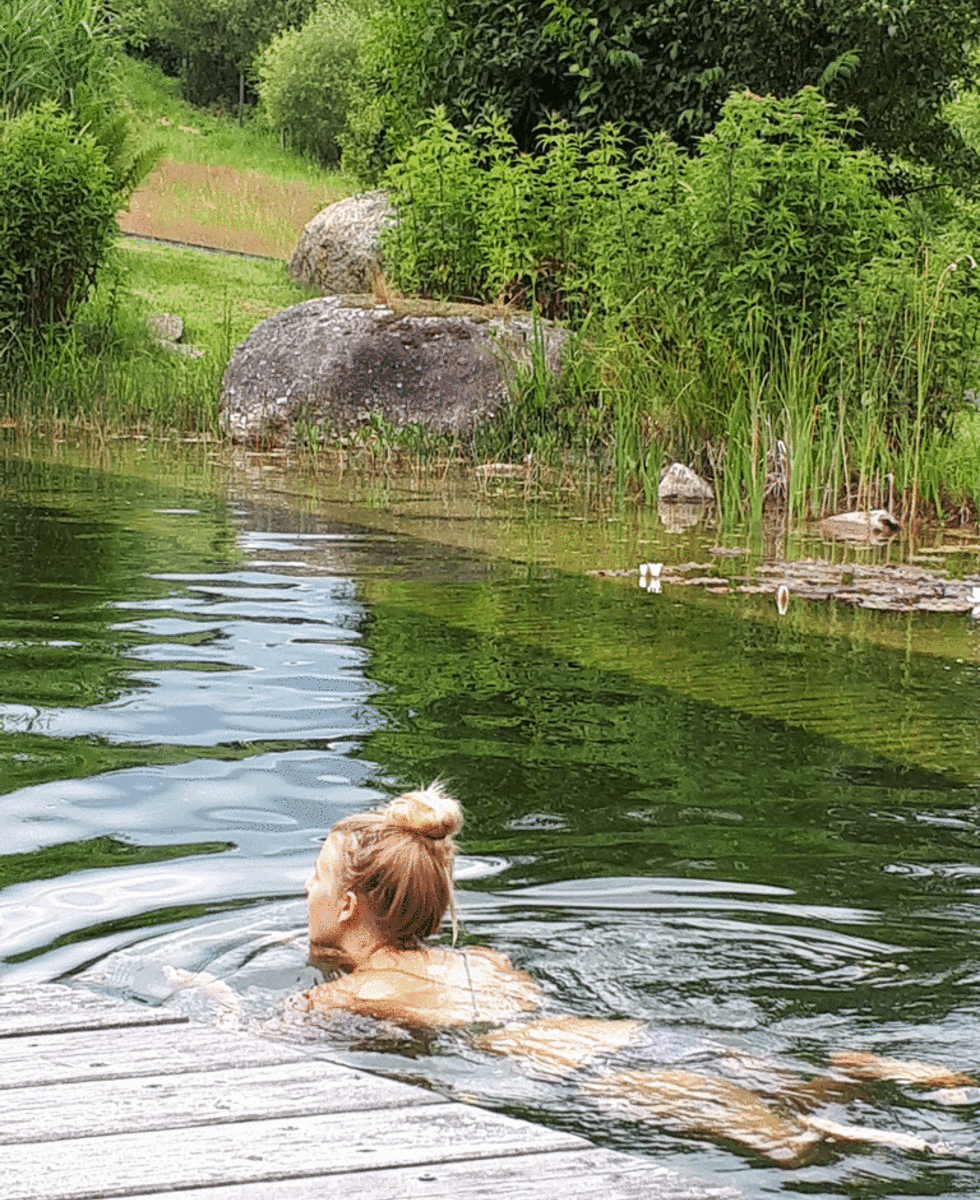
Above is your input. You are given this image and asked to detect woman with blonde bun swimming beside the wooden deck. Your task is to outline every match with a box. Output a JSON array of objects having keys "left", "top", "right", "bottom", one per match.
[{"left": 290, "top": 784, "right": 976, "bottom": 1166}]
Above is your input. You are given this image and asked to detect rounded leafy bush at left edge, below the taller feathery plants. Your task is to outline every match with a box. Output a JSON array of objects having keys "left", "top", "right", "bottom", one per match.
[{"left": 0, "top": 103, "right": 119, "bottom": 335}]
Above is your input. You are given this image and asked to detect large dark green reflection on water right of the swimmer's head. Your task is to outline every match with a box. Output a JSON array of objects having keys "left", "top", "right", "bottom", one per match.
[{"left": 352, "top": 580, "right": 978, "bottom": 906}]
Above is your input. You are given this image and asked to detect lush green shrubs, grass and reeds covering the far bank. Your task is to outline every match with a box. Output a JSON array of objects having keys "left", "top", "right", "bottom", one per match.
[{"left": 0, "top": 0, "right": 980, "bottom": 520}]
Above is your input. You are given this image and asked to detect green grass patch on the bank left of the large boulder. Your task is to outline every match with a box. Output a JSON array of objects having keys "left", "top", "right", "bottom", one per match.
[{"left": 0, "top": 237, "right": 309, "bottom": 437}]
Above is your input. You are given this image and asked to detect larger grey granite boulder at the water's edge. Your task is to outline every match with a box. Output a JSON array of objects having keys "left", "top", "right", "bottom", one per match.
[{"left": 221, "top": 296, "right": 564, "bottom": 440}]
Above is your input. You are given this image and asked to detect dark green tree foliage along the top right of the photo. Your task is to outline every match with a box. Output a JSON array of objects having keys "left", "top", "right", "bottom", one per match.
[{"left": 362, "top": 0, "right": 980, "bottom": 174}]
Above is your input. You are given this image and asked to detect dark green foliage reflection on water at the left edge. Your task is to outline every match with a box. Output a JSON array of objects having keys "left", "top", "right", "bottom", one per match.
[{"left": 0, "top": 457, "right": 236, "bottom": 806}]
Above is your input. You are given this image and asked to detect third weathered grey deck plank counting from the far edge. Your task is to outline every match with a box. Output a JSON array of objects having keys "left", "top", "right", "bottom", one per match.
[{"left": 0, "top": 1058, "right": 447, "bottom": 1145}]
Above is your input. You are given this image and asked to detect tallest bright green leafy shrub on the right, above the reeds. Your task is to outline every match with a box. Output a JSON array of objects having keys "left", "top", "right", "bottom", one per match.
[{"left": 651, "top": 88, "right": 900, "bottom": 336}]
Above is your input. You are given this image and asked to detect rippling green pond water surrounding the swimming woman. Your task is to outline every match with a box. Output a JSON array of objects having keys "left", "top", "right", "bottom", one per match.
[{"left": 0, "top": 446, "right": 980, "bottom": 1198}]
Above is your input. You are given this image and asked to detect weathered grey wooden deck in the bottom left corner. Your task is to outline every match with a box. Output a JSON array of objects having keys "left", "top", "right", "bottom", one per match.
[{"left": 0, "top": 984, "right": 738, "bottom": 1200}]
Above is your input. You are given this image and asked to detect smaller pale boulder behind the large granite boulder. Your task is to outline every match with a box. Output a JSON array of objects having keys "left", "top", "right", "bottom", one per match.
[{"left": 289, "top": 192, "right": 393, "bottom": 295}]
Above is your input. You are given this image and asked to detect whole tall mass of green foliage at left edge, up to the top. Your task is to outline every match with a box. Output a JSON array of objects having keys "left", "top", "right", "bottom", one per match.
[{"left": 0, "top": 0, "right": 152, "bottom": 341}]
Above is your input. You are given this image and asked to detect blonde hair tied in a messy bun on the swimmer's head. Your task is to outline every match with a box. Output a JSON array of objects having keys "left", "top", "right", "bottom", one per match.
[{"left": 327, "top": 782, "right": 463, "bottom": 949}]
